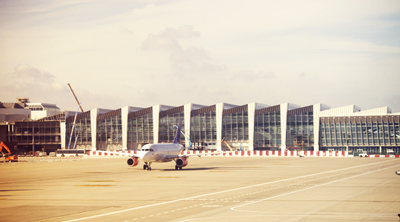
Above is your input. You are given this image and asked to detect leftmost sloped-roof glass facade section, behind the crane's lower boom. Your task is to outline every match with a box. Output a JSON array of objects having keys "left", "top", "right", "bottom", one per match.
[{"left": 65, "top": 111, "right": 92, "bottom": 149}]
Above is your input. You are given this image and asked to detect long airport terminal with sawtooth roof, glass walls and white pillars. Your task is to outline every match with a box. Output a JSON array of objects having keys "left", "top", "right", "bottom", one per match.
[{"left": 1, "top": 100, "right": 400, "bottom": 153}]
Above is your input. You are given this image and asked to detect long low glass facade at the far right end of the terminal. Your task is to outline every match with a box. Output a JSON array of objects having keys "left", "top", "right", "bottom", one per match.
[{"left": 320, "top": 116, "right": 400, "bottom": 146}]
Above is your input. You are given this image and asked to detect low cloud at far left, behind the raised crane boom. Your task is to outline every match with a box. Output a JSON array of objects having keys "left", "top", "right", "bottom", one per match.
[{"left": 0, "top": 64, "right": 126, "bottom": 111}]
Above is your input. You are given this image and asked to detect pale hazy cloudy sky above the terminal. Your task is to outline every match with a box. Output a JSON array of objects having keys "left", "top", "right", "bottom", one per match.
[{"left": 0, "top": 0, "right": 400, "bottom": 113}]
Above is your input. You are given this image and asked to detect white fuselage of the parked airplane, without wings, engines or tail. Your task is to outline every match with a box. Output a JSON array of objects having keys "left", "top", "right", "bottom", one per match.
[{"left": 138, "top": 143, "right": 183, "bottom": 163}]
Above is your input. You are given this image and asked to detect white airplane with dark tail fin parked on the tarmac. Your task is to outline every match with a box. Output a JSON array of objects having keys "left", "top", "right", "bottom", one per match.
[{"left": 127, "top": 119, "right": 214, "bottom": 171}]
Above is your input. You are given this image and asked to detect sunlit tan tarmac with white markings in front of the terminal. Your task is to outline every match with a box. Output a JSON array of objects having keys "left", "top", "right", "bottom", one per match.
[{"left": 0, "top": 157, "right": 400, "bottom": 222}]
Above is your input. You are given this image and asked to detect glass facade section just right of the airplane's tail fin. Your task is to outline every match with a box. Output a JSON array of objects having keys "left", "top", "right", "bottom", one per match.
[{"left": 190, "top": 106, "right": 217, "bottom": 144}]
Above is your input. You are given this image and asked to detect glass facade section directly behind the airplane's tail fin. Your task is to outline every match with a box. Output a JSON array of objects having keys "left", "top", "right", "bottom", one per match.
[{"left": 158, "top": 106, "right": 185, "bottom": 143}]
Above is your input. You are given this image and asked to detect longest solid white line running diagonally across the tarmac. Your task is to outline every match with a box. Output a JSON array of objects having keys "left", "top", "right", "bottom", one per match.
[{"left": 65, "top": 159, "right": 397, "bottom": 222}]
